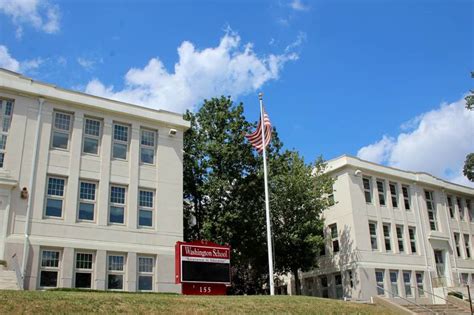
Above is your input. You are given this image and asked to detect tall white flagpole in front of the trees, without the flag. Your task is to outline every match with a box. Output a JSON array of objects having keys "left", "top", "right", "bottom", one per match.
[{"left": 258, "top": 93, "right": 275, "bottom": 295}]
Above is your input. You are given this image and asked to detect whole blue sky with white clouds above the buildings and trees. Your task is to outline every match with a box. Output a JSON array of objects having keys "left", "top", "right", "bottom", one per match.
[{"left": 0, "top": 0, "right": 474, "bottom": 186}]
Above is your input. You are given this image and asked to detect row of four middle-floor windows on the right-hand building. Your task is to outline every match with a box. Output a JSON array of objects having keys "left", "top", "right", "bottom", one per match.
[{"left": 369, "top": 221, "right": 417, "bottom": 254}]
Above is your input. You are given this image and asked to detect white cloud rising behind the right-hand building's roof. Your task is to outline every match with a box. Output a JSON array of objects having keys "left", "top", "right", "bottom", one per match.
[{"left": 357, "top": 98, "right": 474, "bottom": 187}]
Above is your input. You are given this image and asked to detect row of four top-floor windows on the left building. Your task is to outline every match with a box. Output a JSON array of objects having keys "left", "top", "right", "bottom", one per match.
[{"left": 51, "top": 111, "right": 157, "bottom": 164}]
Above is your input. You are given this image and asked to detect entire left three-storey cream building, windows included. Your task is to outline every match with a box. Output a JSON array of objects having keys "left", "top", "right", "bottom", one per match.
[{"left": 0, "top": 70, "right": 189, "bottom": 292}]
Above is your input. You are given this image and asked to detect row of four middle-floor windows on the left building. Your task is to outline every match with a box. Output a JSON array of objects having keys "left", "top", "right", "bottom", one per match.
[{"left": 44, "top": 176, "right": 155, "bottom": 227}]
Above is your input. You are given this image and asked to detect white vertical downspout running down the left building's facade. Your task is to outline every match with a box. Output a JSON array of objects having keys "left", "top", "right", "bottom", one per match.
[{"left": 21, "top": 97, "right": 44, "bottom": 285}]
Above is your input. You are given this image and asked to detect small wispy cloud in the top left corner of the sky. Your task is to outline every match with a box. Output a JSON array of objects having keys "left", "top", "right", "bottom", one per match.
[{"left": 0, "top": 0, "right": 61, "bottom": 38}]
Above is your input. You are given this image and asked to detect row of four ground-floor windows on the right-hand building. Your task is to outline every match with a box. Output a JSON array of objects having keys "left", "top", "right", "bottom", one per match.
[{"left": 375, "top": 269, "right": 425, "bottom": 298}]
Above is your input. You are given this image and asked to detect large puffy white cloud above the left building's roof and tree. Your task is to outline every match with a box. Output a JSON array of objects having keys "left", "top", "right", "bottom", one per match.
[{"left": 86, "top": 31, "right": 298, "bottom": 112}]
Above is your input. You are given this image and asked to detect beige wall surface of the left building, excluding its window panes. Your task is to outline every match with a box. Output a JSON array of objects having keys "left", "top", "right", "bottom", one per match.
[{"left": 0, "top": 70, "right": 189, "bottom": 292}]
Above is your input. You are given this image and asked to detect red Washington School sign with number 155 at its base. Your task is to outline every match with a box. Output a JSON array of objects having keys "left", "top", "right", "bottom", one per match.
[{"left": 175, "top": 241, "right": 230, "bottom": 295}]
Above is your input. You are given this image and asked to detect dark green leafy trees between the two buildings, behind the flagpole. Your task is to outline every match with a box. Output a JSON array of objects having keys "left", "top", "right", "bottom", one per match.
[{"left": 183, "top": 97, "right": 332, "bottom": 294}]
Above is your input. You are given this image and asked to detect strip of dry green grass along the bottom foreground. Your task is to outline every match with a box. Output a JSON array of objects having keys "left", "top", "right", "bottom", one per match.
[{"left": 0, "top": 291, "right": 392, "bottom": 314}]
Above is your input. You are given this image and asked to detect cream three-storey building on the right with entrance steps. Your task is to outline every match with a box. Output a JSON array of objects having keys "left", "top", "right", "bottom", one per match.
[{"left": 292, "top": 156, "right": 474, "bottom": 304}]
